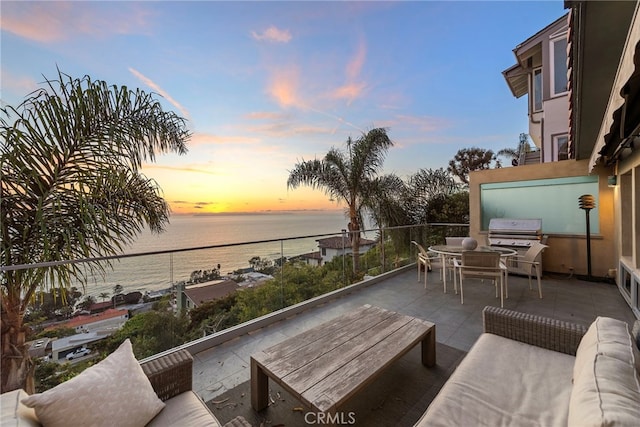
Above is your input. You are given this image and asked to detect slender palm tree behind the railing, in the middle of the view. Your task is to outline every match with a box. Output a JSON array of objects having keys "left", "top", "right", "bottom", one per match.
[{"left": 287, "top": 128, "right": 393, "bottom": 274}]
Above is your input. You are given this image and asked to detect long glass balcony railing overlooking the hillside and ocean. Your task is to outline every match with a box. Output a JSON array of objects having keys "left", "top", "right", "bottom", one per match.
[{"left": 0, "top": 224, "right": 468, "bottom": 390}]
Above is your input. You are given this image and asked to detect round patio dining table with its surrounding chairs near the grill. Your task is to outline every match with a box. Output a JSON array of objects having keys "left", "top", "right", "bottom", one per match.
[{"left": 411, "top": 237, "right": 547, "bottom": 307}]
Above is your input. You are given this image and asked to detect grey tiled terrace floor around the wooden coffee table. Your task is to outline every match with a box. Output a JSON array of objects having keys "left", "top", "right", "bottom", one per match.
[{"left": 176, "top": 265, "right": 635, "bottom": 425}]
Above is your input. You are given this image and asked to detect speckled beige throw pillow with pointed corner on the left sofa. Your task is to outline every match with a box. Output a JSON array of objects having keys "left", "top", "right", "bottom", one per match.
[{"left": 22, "top": 339, "right": 165, "bottom": 427}]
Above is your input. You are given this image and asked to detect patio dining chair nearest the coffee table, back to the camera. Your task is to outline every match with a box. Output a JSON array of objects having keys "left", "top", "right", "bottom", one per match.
[{"left": 453, "top": 251, "right": 507, "bottom": 307}]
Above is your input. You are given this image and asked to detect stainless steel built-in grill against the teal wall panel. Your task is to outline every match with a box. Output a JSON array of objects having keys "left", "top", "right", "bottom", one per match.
[{"left": 487, "top": 218, "right": 547, "bottom": 270}]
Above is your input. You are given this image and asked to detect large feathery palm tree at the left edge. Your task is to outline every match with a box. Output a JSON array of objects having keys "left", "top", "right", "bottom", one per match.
[{"left": 0, "top": 71, "right": 190, "bottom": 392}]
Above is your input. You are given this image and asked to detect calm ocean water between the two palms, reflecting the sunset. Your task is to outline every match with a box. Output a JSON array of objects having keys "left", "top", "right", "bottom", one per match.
[{"left": 83, "top": 210, "right": 356, "bottom": 301}]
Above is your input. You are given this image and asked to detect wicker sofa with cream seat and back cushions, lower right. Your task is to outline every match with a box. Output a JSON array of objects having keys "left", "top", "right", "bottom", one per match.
[{"left": 416, "top": 307, "right": 640, "bottom": 427}]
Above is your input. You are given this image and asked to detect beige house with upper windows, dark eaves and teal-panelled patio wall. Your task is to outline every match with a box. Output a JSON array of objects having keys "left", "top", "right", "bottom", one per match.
[{"left": 469, "top": 1, "right": 640, "bottom": 318}]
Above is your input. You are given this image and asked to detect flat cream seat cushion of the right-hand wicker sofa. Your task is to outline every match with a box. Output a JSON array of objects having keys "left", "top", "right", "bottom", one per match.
[{"left": 416, "top": 333, "right": 575, "bottom": 427}]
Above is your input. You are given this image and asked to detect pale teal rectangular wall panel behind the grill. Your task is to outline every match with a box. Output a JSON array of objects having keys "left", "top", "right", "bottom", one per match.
[{"left": 480, "top": 176, "right": 600, "bottom": 234}]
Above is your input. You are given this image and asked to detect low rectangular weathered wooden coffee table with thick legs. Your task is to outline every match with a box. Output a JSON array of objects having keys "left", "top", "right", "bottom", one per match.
[{"left": 251, "top": 305, "right": 436, "bottom": 412}]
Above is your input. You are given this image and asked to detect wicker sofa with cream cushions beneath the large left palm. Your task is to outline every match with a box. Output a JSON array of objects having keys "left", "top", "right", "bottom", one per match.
[{"left": 0, "top": 340, "right": 251, "bottom": 427}]
